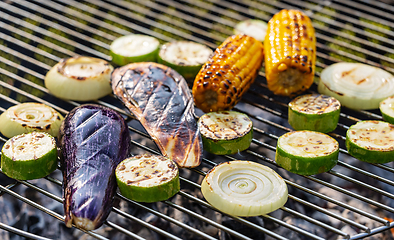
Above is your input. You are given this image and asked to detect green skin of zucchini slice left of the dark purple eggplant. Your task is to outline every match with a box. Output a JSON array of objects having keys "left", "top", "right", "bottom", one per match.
[{"left": 1, "top": 132, "right": 58, "bottom": 180}]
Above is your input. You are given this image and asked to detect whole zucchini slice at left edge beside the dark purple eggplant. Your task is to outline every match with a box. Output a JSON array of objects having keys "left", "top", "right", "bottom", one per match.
[{"left": 1, "top": 132, "right": 57, "bottom": 180}]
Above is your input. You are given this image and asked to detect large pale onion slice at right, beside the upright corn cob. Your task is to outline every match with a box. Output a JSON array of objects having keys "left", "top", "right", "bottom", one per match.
[{"left": 318, "top": 62, "right": 394, "bottom": 110}]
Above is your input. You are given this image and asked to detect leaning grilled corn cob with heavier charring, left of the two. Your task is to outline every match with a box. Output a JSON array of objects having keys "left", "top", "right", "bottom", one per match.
[{"left": 193, "top": 34, "right": 264, "bottom": 112}]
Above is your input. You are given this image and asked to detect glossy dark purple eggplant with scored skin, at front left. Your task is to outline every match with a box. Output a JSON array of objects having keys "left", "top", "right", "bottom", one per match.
[{"left": 58, "top": 104, "right": 130, "bottom": 230}]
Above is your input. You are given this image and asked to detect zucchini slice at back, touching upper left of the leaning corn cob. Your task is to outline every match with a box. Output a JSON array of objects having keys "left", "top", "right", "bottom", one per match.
[{"left": 158, "top": 41, "right": 213, "bottom": 84}]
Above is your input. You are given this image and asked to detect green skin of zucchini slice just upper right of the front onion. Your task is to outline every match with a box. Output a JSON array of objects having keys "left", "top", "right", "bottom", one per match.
[{"left": 275, "top": 131, "right": 339, "bottom": 176}]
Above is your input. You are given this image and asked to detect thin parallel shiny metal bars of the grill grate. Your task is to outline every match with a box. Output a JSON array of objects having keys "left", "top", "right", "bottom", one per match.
[{"left": 0, "top": 0, "right": 394, "bottom": 239}]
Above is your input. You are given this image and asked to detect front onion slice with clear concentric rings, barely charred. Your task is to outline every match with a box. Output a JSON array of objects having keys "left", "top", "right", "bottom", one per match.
[{"left": 201, "top": 160, "right": 288, "bottom": 217}]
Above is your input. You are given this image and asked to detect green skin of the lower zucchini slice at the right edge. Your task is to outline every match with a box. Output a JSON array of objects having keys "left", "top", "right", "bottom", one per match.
[{"left": 346, "top": 121, "right": 394, "bottom": 163}]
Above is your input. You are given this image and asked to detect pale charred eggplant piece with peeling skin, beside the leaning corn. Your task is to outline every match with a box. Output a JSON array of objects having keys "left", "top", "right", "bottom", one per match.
[{"left": 112, "top": 62, "right": 202, "bottom": 167}]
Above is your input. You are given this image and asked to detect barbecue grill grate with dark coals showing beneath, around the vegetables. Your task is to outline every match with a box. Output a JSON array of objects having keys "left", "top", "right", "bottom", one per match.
[{"left": 0, "top": 0, "right": 394, "bottom": 239}]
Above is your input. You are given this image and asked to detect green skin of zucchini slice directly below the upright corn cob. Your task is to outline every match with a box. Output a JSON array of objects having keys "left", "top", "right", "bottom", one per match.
[{"left": 288, "top": 94, "right": 341, "bottom": 133}]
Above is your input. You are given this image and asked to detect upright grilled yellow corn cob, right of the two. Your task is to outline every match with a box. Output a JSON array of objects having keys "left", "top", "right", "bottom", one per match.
[{"left": 264, "top": 9, "right": 316, "bottom": 96}]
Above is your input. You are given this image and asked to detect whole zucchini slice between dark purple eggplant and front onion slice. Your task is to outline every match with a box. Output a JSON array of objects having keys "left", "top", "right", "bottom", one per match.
[{"left": 115, "top": 154, "right": 180, "bottom": 202}]
